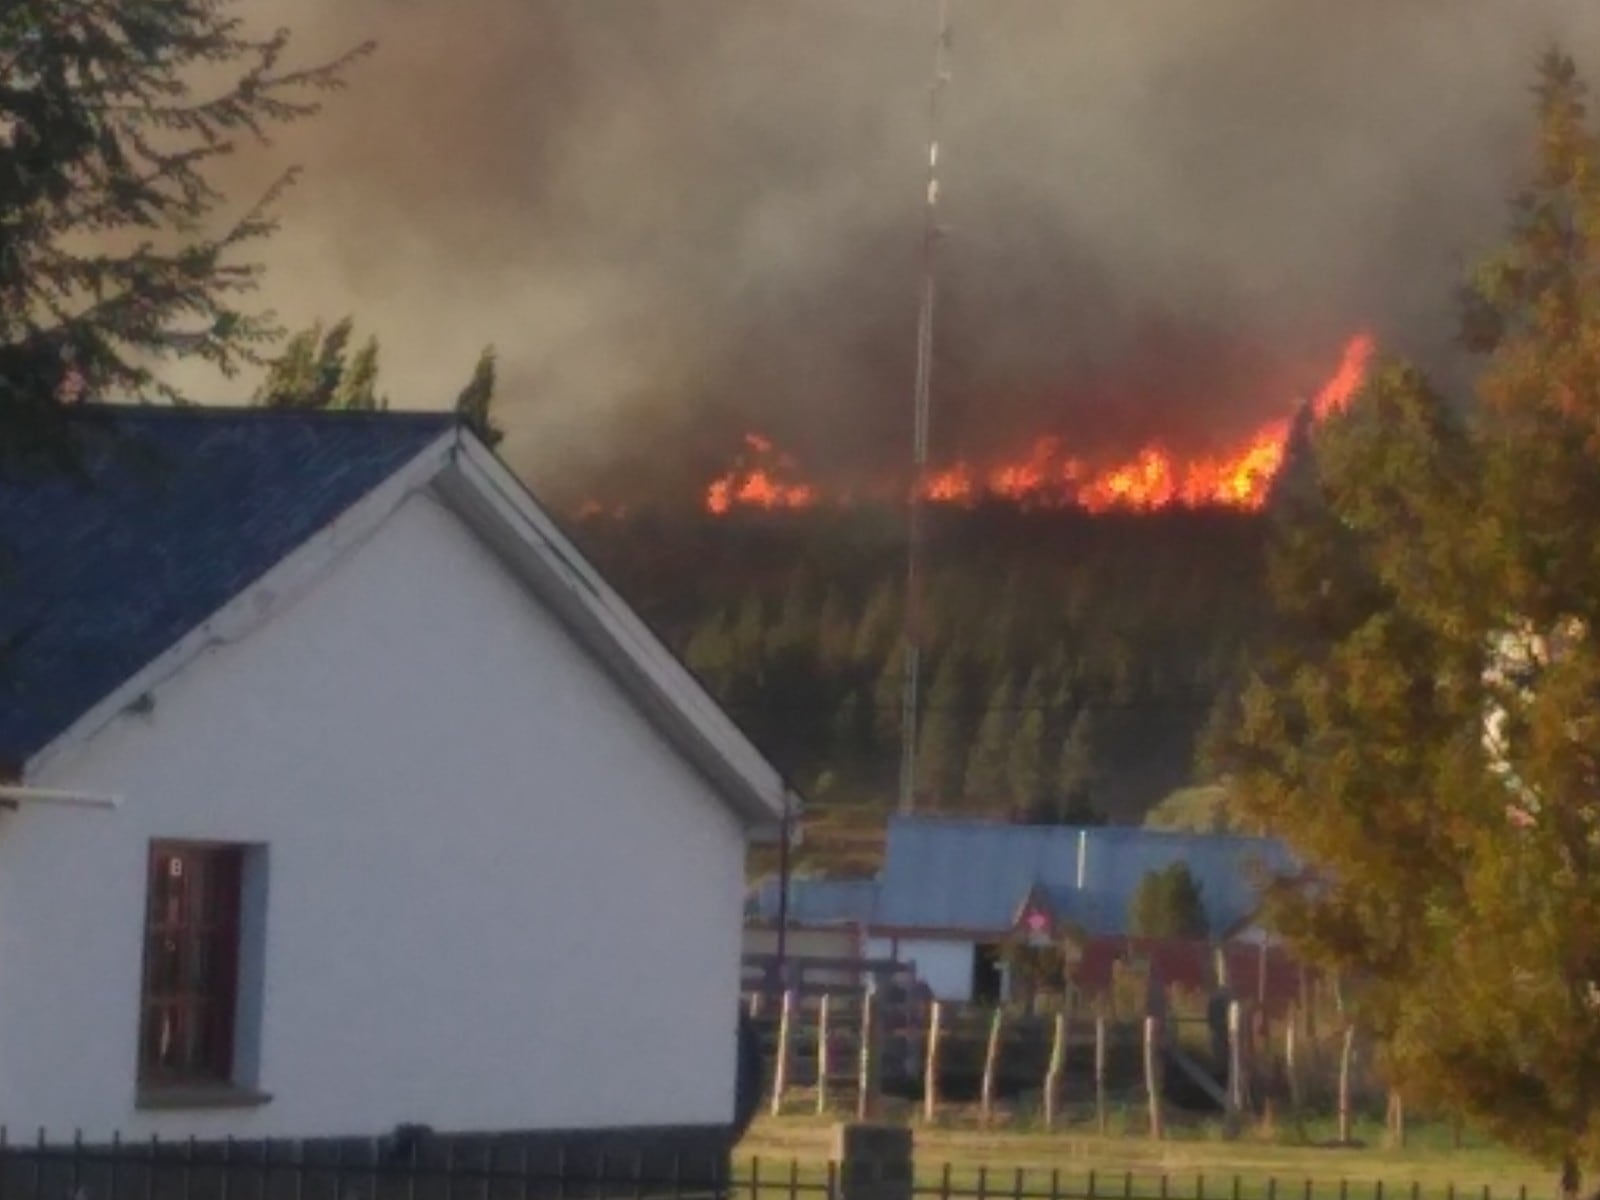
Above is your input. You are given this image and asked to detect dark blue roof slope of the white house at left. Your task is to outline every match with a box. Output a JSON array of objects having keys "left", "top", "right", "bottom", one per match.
[{"left": 0, "top": 406, "right": 456, "bottom": 766}]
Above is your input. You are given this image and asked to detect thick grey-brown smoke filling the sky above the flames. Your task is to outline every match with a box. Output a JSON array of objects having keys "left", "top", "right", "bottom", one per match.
[{"left": 196, "top": 0, "right": 1600, "bottom": 508}]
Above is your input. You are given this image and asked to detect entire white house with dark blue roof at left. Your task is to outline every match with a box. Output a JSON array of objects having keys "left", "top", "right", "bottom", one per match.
[{"left": 0, "top": 410, "right": 786, "bottom": 1142}]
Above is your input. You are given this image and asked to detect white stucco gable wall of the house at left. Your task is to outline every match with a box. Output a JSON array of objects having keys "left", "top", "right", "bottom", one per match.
[{"left": 0, "top": 496, "right": 744, "bottom": 1138}]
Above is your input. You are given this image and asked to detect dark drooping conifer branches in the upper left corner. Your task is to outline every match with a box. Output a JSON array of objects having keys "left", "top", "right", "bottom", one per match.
[{"left": 0, "top": 0, "right": 368, "bottom": 466}]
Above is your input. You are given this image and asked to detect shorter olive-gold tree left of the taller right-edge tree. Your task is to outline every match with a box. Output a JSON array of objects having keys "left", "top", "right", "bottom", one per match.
[{"left": 1219, "top": 355, "right": 1483, "bottom": 1120}]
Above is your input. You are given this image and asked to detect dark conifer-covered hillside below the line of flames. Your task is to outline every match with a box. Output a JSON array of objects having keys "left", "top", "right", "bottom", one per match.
[{"left": 574, "top": 506, "right": 1264, "bottom": 851}]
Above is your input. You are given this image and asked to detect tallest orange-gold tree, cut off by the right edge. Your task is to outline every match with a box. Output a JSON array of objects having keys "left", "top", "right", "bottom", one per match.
[{"left": 1446, "top": 53, "right": 1600, "bottom": 1192}]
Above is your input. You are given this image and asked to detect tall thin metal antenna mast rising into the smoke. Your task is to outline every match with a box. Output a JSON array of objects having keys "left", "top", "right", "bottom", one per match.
[{"left": 899, "top": 0, "right": 950, "bottom": 813}]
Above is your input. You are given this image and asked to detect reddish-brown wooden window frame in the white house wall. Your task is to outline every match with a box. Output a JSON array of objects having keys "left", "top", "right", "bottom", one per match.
[{"left": 139, "top": 842, "right": 245, "bottom": 1086}]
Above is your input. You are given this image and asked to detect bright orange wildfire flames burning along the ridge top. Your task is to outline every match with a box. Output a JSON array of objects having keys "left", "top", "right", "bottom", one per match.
[{"left": 706, "top": 333, "right": 1376, "bottom": 515}]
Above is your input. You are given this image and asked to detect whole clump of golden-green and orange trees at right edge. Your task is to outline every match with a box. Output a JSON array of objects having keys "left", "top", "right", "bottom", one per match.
[{"left": 1222, "top": 53, "right": 1600, "bottom": 1195}]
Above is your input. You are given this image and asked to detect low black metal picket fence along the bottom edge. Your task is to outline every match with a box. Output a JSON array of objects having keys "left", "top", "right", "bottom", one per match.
[{"left": 0, "top": 1131, "right": 1554, "bottom": 1200}]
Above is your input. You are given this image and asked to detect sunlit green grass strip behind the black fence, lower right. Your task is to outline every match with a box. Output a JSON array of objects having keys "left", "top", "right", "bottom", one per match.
[{"left": 736, "top": 1114, "right": 1555, "bottom": 1200}]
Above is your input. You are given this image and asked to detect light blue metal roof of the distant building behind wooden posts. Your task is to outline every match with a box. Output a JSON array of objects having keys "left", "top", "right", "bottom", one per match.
[{"left": 875, "top": 818, "right": 1291, "bottom": 934}]
